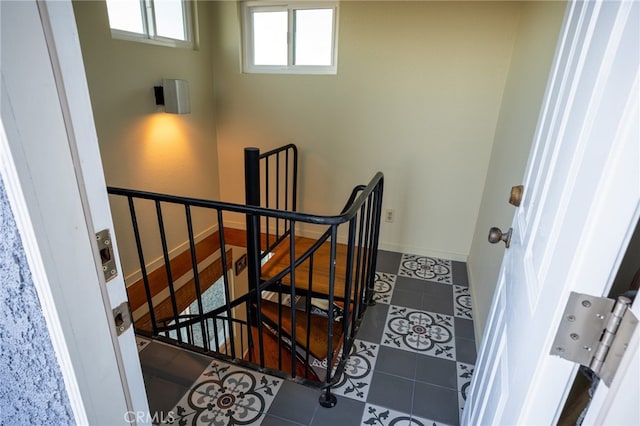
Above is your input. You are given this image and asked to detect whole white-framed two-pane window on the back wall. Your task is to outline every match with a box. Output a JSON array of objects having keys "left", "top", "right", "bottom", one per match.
[{"left": 243, "top": 1, "right": 338, "bottom": 74}]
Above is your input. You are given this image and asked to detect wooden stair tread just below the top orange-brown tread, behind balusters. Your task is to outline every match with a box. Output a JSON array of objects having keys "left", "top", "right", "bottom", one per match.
[{"left": 262, "top": 300, "right": 342, "bottom": 360}]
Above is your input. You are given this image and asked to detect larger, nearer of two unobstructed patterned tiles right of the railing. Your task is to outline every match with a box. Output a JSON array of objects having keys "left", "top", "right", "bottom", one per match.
[{"left": 381, "top": 305, "right": 456, "bottom": 360}]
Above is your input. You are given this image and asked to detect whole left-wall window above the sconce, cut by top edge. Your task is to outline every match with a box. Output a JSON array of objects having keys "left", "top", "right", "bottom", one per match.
[{"left": 107, "top": 0, "right": 192, "bottom": 47}]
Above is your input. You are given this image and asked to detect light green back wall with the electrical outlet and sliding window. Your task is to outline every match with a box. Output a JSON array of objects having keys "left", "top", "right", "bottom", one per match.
[{"left": 213, "top": 1, "right": 522, "bottom": 260}]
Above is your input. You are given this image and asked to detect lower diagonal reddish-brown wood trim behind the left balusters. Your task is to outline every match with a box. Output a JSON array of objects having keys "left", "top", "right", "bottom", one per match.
[{"left": 135, "top": 249, "right": 233, "bottom": 332}]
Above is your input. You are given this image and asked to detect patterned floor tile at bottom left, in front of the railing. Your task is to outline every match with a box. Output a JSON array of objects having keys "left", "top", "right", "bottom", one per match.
[{"left": 165, "top": 361, "right": 282, "bottom": 426}]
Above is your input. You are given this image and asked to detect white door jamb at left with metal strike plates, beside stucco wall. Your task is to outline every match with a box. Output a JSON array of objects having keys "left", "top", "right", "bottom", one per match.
[{"left": 0, "top": 1, "right": 151, "bottom": 425}]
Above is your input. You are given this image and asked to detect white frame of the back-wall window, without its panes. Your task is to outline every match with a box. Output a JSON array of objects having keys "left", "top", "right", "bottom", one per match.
[{"left": 242, "top": 0, "right": 339, "bottom": 75}]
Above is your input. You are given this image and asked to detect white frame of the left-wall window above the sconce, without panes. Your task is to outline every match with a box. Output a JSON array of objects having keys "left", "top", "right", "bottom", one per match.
[{"left": 107, "top": 0, "right": 197, "bottom": 48}]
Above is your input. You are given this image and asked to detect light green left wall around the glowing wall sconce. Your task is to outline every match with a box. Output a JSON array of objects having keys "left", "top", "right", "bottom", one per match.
[{"left": 73, "top": 1, "right": 220, "bottom": 275}]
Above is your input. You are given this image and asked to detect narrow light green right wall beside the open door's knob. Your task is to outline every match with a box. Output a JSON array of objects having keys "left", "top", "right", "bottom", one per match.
[{"left": 467, "top": 2, "right": 566, "bottom": 344}]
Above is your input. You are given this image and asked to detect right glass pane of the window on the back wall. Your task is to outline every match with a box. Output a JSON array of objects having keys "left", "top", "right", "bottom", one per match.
[{"left": 294, "top": 9, "right": 333, "bottom": 65}]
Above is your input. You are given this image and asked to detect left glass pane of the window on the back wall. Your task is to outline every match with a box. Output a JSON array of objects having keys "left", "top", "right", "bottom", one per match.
[{"left": 252, "top": 11, "right": 287, "bottom": 65}]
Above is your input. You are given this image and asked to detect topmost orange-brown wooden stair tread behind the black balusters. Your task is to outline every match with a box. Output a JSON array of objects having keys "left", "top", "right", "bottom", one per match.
[{"left": 260, "top": 237, "right": 353, "bottom": 298}]
